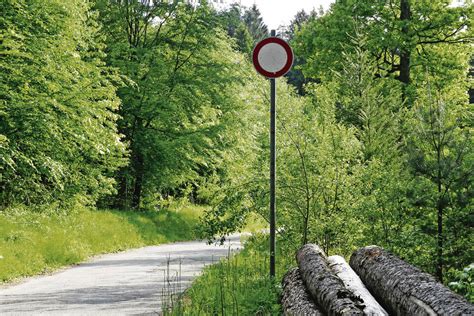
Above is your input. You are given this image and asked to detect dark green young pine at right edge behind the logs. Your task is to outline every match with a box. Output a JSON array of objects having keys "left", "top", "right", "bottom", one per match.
[{"left": 409, "top": 86, "right": 473, "bottom": 280}]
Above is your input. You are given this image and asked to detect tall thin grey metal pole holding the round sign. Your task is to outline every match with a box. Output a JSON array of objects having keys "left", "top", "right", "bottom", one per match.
[{"left": 270, "top": 30, "right": 276, "bottom": 278}]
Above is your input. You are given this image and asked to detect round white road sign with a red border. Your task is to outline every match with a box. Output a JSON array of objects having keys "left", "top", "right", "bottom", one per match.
[{"left": 253, "top": 37, "right": 293, "bottom": 78}]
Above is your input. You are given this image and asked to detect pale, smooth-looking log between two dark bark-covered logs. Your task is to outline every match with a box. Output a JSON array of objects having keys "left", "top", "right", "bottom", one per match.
[{"left": 328, "top": 256, "right": 388, "bottom": 316}]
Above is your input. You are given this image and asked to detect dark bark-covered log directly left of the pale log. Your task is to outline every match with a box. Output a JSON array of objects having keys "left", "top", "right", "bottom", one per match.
[{"left": 296, "top": 244, "right": 364, "bottom": 315}]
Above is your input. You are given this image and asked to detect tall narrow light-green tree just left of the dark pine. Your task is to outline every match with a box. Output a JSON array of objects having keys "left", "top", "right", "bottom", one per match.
[{"left": 334, "top": 39, "right": 424, "bottom": 265}]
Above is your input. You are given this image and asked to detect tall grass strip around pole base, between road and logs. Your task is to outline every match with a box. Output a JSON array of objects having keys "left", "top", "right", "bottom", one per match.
[{"left": 165, "top": 237, "right": 292, "bottom": 315}]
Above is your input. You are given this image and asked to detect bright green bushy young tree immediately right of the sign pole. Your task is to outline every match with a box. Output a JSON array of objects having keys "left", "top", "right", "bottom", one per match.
[{"left": 278, "top": 87, "right": 360, "bottom": 253}]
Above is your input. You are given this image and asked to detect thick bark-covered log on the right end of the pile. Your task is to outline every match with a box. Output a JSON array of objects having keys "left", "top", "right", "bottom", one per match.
[{"left": 350, "top": 246, "right": 474, "bottom": 316}]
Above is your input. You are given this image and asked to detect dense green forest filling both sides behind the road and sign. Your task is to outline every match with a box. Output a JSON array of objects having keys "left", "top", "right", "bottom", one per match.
[{"left": 0, "top": 0, "right": 474, "bottom": 294}]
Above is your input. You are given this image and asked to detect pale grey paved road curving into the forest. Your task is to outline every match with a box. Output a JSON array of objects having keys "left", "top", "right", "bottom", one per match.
[{"left": 0, "top": 236, "right": 241, "bottom": 315}]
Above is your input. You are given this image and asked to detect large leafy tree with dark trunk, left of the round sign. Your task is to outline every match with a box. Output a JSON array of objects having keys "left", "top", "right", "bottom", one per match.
[{"left": 94, "top": 1, "right": 262, "bottom": 208}]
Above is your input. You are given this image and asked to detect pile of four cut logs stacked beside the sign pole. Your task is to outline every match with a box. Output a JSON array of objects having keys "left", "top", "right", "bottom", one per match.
[{"left": 282, "top": 244, "right": 474, "bottom": 316}]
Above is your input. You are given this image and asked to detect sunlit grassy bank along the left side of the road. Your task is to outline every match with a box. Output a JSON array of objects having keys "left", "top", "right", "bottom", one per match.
[{"left": 0, "top": 206, "right": 202, "bottom": 282}]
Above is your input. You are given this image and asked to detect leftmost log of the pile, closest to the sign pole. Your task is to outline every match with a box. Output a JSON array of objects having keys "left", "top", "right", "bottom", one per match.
[{"left": 281, "top": 268, "right": 324, "bottom": 316}]
